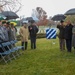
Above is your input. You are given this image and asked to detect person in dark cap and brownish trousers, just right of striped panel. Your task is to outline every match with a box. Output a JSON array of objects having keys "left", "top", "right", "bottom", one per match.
[{"left": 57, "top": 20, "right": 65, "bottom": 50}]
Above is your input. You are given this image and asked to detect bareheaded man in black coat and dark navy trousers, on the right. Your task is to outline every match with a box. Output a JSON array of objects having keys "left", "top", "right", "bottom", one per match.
[{"left": 65, "top": 21, "right": 73, "bottom": 52}]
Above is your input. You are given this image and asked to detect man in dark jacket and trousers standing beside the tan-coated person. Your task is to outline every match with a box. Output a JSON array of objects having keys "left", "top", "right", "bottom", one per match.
[{"left": 28, "top": 20, "right": 38, "bottom": 49}]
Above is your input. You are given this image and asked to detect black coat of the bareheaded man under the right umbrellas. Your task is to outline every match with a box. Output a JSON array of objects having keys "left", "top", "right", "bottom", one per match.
[{"left": 65, "top": 24, "right": 73, "bottom": 39}]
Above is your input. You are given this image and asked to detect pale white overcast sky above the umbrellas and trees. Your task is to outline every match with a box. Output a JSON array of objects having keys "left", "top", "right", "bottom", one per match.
[{"left": 17, "top": 0, "right": 75, "bottom": 17}]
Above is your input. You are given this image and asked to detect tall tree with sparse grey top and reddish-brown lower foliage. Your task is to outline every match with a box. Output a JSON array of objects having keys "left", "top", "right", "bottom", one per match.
[{"left": 32, "top": 7, "right": 49, "bottom": 26}]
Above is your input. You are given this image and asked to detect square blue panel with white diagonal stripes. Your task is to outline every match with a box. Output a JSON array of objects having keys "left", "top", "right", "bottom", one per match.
[{"left": 46, "top": 28, "right": 56, "bottom": 39}]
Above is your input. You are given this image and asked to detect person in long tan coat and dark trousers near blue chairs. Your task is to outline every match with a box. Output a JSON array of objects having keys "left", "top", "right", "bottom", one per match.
[{"left": 19, "top": 22, "right": 29, "bottom": 50}]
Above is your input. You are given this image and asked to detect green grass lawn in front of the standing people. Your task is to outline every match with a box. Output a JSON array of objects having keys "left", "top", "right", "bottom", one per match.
[{"left": 0, "top": 38, "right": 75, "bottom": 75}]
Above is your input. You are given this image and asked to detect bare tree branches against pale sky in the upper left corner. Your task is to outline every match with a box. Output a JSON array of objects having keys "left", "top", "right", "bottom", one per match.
[{"left": 0, "top": 0, "right": 22, "bottom": 13}]
